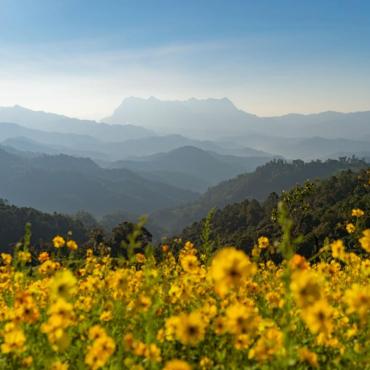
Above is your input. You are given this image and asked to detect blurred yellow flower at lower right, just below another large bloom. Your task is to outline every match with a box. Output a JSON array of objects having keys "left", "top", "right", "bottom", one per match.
[{"left": 302, "top": 300, "right": 334, "bottom": 336}]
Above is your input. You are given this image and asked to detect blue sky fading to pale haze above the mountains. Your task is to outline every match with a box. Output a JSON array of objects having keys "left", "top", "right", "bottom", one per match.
[{"left": 0, "top": 0, "right": 370, "bottom": 120}]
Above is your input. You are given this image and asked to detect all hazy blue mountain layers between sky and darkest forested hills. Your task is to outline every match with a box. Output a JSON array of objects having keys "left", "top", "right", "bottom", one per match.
[{"left": 0, "top": 97, "right": 370, "bottom": 225}]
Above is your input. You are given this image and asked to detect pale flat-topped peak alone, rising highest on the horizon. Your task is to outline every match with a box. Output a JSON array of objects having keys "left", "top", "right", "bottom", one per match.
[{"left": 103, "top": 96, "right": 257, "bottom": 138}]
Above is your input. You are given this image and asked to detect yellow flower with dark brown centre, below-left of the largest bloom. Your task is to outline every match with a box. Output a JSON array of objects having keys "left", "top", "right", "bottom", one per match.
[{"left": 176, "top": 312, "right": 205, "bottom": 345}]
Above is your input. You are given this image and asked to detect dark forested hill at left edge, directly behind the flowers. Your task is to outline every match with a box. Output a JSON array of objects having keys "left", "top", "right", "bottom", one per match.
[{"left": 0, "top": 199, "right": 88, "bottom": 252}]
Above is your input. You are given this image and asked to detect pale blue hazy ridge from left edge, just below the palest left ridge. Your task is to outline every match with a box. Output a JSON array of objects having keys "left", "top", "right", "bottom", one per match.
[{"left": 0, "top": 121, "right": 273, "bottom": 161}]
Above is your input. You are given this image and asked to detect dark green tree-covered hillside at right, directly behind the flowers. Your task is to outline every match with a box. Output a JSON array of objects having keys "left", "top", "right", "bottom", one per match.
[{"left": 181, "top": 169, "right": 370, "bottom": 256}]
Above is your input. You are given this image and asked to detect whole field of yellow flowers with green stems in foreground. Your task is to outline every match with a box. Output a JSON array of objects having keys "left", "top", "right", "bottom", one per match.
[{"left": 0, "top": 209, "right": 370, "bottom": 370}]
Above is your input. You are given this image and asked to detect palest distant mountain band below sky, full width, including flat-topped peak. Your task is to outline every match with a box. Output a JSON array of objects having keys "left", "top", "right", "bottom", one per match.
[{"left": 0, "top": 97, "right": 370, "bottom": 165}]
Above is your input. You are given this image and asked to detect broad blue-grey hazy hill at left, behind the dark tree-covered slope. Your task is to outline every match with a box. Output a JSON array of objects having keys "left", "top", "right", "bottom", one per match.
[{"left": 0, "top": 149, "right": 197, "bottom": 216}]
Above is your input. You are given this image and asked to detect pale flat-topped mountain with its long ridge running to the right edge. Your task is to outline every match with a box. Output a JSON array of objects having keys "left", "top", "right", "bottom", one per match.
[{"left": 103, "top": 97, "right": 370, "bottom": 139}]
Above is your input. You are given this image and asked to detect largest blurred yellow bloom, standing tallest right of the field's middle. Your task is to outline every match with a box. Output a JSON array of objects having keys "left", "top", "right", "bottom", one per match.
[{"left": 210, "top": 247, "right": 256, "bottom": 295}]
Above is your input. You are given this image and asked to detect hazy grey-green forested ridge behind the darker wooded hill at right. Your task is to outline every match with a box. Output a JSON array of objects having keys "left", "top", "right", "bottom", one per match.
[{"left": 152, "top": 158, "right": 367, "bottom": 234}]
